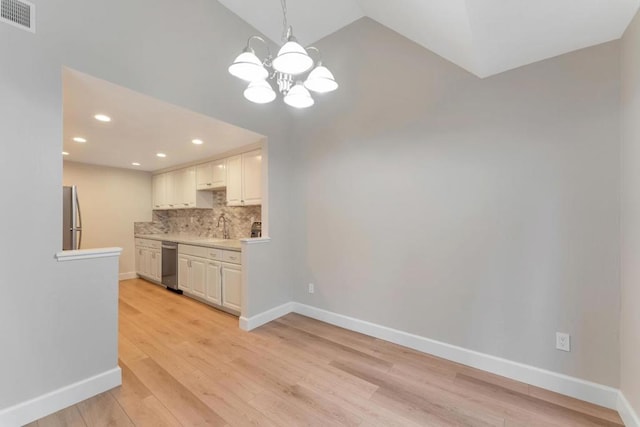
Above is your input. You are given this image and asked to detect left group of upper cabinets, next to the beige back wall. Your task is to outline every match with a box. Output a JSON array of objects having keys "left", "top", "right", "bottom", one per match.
[{"left": 152, "top": 166, "right": 213, "bottom": 209}]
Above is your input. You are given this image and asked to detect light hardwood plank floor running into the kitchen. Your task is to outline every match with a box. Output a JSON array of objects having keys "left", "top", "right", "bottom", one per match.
[{"left": 29, "top": 280, "right": 622, "bottom": 427}]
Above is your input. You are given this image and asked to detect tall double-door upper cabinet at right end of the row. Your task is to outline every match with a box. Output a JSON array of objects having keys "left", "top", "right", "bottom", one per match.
[{"left": 226, "top": 150, "right": 262, "bottom": 206}]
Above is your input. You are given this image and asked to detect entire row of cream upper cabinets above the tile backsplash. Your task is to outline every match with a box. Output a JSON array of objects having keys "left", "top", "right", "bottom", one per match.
[{"left": 152, "top": 149, "right": 262, "bottom": 210}]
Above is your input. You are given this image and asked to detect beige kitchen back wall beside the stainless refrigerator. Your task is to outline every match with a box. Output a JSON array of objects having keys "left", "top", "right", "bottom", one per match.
[{"left": 62, "top": 161, "right": 151, "bottom": 274}]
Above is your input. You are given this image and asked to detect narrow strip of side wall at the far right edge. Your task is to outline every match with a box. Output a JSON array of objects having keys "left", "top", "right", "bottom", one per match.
[{"left": 620, "top": 8, "right": 640, "bottom": 420}]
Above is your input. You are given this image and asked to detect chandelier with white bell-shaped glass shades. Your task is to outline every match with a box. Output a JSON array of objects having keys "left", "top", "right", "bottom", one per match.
[{"left": 229, "top": 0, "right": 338, "bottom": 108}]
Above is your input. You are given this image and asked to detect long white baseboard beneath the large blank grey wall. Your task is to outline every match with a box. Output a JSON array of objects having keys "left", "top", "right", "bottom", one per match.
[{"left": 293, "top": 303, "right": 630, "bottom": 409}]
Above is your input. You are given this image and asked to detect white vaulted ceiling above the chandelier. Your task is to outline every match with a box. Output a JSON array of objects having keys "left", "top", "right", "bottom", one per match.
[{"left": 218, "top": 0, "right": 640, "bottom": 77}]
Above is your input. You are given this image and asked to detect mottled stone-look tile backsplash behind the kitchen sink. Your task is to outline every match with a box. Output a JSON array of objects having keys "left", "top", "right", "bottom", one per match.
[{"left": 134, "top": 190, "right": 262, "bottom": 239}]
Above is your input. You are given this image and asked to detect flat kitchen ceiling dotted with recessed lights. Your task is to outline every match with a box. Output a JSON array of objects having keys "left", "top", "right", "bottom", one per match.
[{"left": 63, "top": 69, "right": 263, "bottom": 171}]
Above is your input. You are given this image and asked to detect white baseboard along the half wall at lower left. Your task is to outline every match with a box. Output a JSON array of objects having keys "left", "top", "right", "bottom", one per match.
[{"left": 0, "top": 367, "right": 122, "bottom": 427}]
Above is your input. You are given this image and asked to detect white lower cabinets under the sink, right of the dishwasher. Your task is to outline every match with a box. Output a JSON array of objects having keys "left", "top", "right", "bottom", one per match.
[{"left": 178, "top": 245, "right": 242, "bottom": 314}]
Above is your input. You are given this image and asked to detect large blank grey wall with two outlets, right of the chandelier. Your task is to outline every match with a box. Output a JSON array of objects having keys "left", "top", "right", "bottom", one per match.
[{"left": 292, "top": 19, "right": 620, "bottom": 386}]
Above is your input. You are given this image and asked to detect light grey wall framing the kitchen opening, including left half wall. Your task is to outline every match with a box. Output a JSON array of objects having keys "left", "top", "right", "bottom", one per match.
[{"left": 0, "top": 0, "right": 291, "bottom": 416}]
